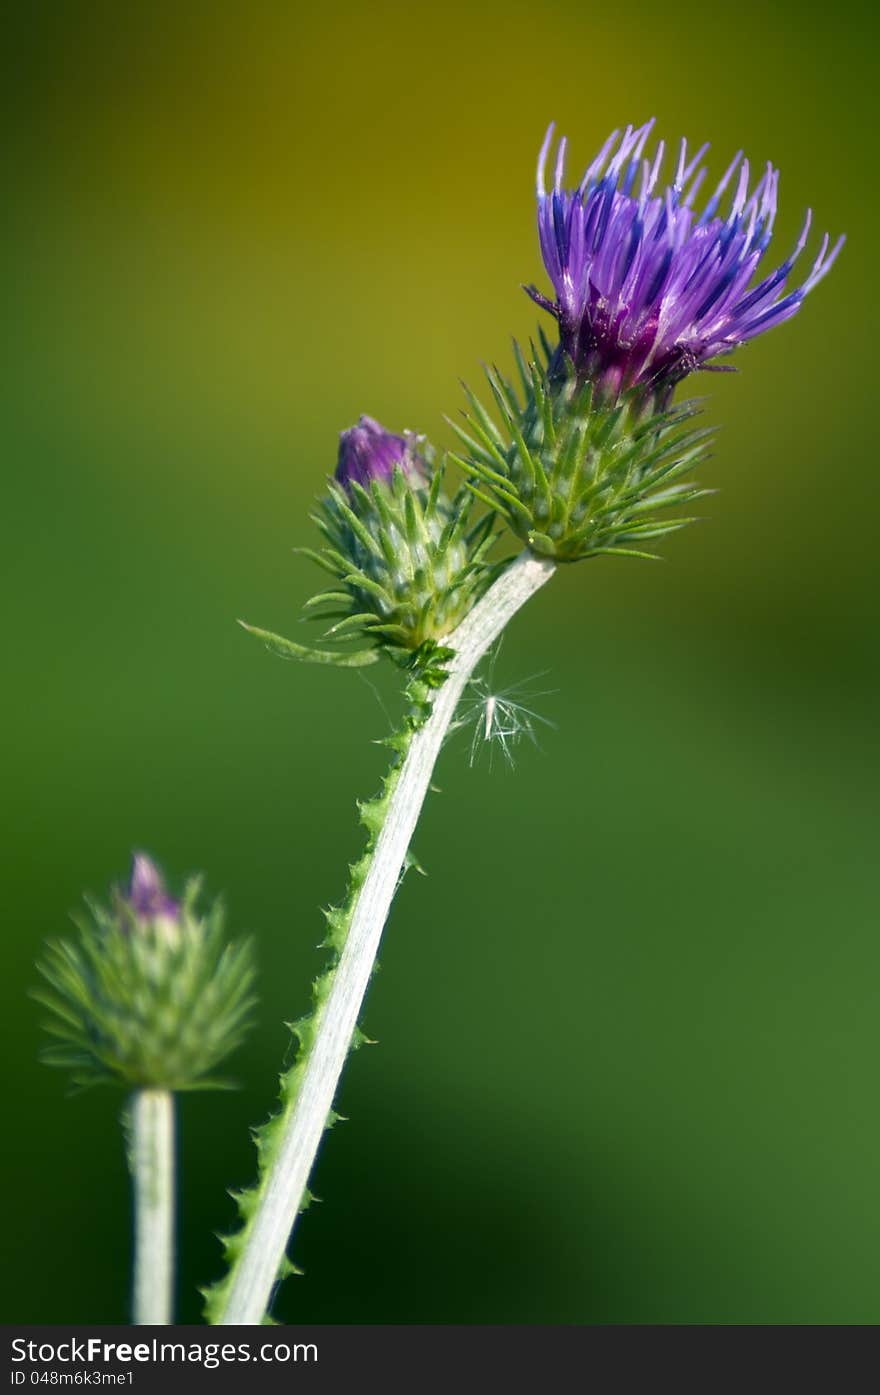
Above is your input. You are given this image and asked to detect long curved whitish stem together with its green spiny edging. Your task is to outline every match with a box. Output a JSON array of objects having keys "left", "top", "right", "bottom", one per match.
[{"left": 206, "top": 552, "right": 555, "bottom": 1324}]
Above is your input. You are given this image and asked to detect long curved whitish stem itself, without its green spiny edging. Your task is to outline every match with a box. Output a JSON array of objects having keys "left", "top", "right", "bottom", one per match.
[{"left": 213, "top": 552, "right": 555, "bottom": 1324}]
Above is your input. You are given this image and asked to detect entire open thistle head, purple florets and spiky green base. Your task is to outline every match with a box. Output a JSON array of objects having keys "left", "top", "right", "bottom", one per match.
[{"left": 456, "top": 121, "right": 842, "bottom": 562}]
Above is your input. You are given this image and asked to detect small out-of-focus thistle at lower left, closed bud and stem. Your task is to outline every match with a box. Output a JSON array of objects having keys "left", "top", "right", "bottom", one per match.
[{"left": 33, "top": 852, "right": 254, "bottom": 1324}]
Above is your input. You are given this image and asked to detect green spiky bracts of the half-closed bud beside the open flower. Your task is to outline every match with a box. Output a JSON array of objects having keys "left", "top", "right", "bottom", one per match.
[{"left": 303, "top": 452, "right": 498, "bottom": 657}]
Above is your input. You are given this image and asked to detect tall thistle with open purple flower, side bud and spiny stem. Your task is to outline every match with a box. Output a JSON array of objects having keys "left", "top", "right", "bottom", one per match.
[{"left": 198, "top": 123, "right": 842, "bottom": 1322}]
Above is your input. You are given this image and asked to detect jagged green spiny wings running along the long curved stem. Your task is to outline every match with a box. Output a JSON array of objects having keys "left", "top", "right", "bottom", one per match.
[{"left": 202, "top": 664, "right": 437, "bottom": 1324}]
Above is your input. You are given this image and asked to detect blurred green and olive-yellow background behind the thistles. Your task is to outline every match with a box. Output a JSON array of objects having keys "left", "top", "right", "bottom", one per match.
[{"left": 0, "top": 0, "right": 880, "bottom": 1322}]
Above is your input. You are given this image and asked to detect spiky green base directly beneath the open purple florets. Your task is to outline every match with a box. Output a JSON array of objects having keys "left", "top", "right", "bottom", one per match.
[{"left": 452, "top": 346, "right": 711, "bottom": 562}]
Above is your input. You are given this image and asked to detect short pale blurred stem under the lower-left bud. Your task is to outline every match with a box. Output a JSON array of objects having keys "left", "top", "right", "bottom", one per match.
[{"left": 131, "top": 1089, "right": 174, "bottom": 1325}]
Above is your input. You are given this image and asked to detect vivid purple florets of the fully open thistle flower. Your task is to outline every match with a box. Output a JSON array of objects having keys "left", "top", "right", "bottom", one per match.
[{"left": 526, "top": 120, "right": 844, "bottom": 400}]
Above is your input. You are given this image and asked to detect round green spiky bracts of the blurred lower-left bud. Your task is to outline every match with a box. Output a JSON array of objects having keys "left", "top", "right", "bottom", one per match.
[{"left": 33, "top": 879, "right": 255, "bottom": 1089}]
